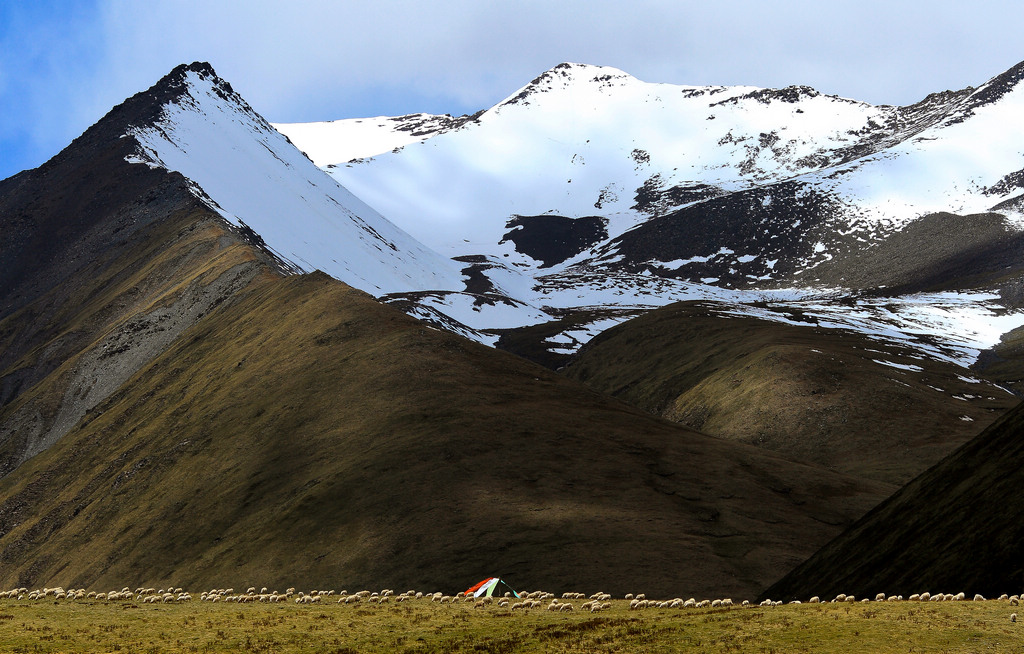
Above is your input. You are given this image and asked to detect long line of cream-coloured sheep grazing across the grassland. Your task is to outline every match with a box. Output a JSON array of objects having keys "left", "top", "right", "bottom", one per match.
[{"left": 0, "top": 586, "right": 1021, "bottom": 622}]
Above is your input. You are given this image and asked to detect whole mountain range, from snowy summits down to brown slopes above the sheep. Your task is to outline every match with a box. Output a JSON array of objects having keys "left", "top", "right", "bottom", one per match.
[{"left": 0, "top": 58, "right": 1024, "bottom": 599}]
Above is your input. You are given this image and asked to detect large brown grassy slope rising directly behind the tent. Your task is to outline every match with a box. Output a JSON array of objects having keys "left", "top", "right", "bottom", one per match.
[{"left": 0, "top": 264, "right": 890, "bottom": 597}]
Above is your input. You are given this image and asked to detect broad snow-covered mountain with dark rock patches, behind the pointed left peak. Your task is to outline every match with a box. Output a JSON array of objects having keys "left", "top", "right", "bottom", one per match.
[{"left": 276, "top": 63, "right": 1024, "bottom": 361}]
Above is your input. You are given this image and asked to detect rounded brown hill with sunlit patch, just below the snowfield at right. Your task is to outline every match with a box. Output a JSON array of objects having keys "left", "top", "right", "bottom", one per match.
[{"left": 565, "top": 302, "right": 1018, "bottom": 483}]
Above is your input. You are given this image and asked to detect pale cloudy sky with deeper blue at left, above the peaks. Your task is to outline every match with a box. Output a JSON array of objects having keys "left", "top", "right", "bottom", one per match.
[{"left": 0, "top": 0, "right": 1024, "bottom": 179}]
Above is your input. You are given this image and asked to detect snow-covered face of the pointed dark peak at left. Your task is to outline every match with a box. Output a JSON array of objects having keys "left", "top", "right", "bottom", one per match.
[{"left": 128, "top": 64, "right": 462, "bottom": 295}]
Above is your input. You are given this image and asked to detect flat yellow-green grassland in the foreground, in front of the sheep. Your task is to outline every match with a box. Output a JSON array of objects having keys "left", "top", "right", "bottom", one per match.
[{"left": 0, "top": 598, "right": 1024, "bottom": 654}]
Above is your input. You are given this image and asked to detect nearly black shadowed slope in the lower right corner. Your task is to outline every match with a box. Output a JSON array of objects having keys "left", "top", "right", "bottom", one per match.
[{"left": 765, "top": 399, "right": 1024, "bottom": 599}]
